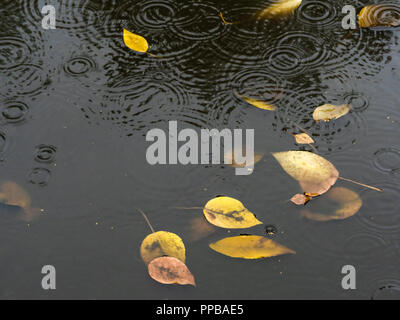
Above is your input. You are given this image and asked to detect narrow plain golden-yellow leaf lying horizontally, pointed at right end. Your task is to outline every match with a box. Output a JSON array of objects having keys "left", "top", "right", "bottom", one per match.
[{"left": 210, "top": 236, "right": 296, "bottom": 259}]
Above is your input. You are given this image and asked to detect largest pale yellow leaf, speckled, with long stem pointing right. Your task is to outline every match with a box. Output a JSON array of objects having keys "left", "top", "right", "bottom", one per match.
[{"left": 272, "top": 151, "right": 339, "bottom": 194}]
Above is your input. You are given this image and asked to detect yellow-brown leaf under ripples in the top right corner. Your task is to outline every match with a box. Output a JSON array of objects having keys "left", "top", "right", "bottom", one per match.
[{"left": 358, "top": 4, "right": 400, "bottom": 28}]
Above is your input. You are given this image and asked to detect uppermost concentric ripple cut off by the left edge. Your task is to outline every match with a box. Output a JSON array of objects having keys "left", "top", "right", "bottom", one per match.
[{"left": 0, "top": 37, "right": 30, "bottom": 70}]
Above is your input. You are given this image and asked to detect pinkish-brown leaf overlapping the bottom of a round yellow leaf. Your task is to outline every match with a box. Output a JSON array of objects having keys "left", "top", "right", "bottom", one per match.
[{"left": 147, "top": 257, "right": 196, "bottom": 286}]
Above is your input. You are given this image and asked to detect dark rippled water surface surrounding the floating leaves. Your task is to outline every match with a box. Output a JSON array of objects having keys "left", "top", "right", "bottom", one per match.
[{"left": 0, "top": 0, "right": 400, "bottom": 299}]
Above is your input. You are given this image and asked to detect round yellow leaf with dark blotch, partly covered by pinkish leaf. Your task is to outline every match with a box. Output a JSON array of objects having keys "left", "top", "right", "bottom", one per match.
[{"left": 140, "top": 231, "right": 186, "bottom": 264}]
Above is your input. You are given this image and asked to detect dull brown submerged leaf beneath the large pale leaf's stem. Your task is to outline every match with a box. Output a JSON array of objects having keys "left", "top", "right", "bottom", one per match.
[{"left": 301, "top": 187, "right": 362, "bottom": 221}]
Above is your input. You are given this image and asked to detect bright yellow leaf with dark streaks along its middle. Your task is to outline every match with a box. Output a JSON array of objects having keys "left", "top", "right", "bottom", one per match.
[{"left": 203, "top": 197, "right": 262, "bottom": 229}]
